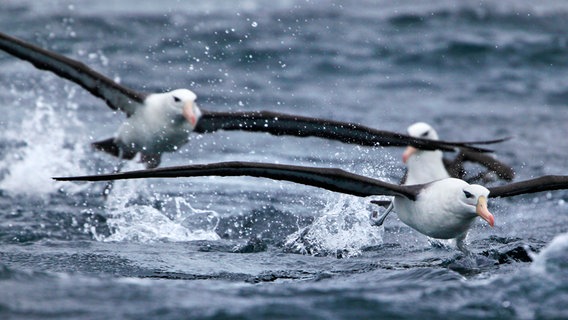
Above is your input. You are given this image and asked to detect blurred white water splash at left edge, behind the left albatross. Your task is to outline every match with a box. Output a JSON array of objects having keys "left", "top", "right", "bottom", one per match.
[{"left": 0, "top": 96, "right": 90, "bottom": 197}]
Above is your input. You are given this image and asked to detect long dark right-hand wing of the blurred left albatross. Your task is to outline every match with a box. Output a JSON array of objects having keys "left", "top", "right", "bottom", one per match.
[{"left": 194, "top": 110, "right": 508, "bottom": 152}]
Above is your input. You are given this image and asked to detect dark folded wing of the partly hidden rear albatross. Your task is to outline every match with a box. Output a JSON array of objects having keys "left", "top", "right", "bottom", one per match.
[{"left": 444, "top": 149, "right": 515, "bottom": 181}]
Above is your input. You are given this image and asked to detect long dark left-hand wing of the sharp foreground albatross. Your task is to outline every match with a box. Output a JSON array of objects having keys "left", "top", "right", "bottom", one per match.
[{"left": 54, "top": 162, "right": 421, "bottom": 199}]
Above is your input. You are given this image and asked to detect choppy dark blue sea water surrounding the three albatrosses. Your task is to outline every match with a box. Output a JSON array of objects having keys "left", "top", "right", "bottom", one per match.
[{"left": 0, "top": 0, "right": 568, "bottom": 319}]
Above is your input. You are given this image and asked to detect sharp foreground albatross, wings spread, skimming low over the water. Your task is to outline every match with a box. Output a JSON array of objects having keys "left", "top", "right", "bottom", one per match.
[{"left": 54, "top": 162, "right": 568, "bottom": 252}]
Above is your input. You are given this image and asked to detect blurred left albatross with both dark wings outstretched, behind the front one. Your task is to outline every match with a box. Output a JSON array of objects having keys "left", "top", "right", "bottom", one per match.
[{"left": 0, "top": 33, "right": 507, "bottom": 169}]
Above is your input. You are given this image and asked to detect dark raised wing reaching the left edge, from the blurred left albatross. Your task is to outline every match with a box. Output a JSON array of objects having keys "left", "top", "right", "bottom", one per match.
[{"left": 0, "top": 33, "right": 146, "bottom": 115}]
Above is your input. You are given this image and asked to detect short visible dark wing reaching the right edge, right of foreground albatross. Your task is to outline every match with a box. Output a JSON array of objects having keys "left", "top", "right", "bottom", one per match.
[{"left": 488, "top": 176, "right": 568, "bottom": 198}]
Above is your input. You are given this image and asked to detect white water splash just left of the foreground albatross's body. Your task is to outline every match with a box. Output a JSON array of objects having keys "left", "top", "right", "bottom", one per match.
[{"left": 285, "top": 195, "right": 384, "bottom": 257}]
